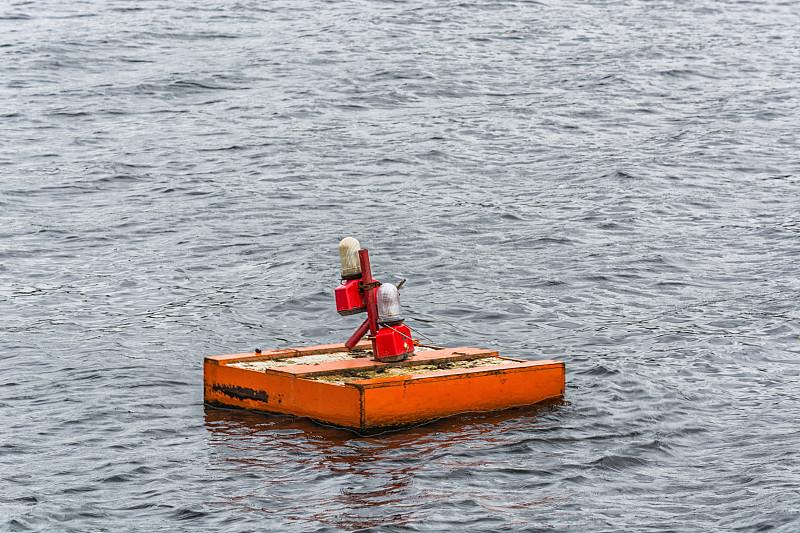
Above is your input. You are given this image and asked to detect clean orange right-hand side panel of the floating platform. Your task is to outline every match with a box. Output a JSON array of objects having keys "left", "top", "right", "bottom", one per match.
[{"left": 362, "top": 361, "right": 564, "bottom": 429}]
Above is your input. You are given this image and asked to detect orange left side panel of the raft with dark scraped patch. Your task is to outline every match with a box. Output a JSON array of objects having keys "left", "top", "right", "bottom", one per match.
[{"left": 204, "top": 361, "right": 361, "bottom": 427}]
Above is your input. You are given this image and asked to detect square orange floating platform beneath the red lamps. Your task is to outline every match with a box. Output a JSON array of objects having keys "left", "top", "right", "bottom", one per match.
[{"left": 204, "top": 343, "right": 564, "bottom": 433}]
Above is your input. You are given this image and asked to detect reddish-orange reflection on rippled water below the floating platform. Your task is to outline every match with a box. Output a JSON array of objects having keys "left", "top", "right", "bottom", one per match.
[{"left": 205, "top": 401, "right": 570, "bottom": 530}]
